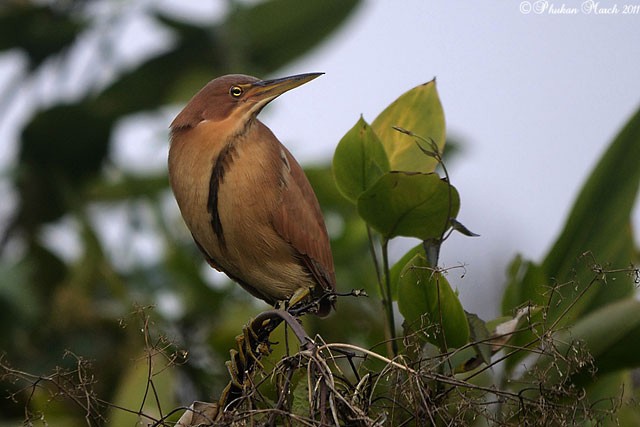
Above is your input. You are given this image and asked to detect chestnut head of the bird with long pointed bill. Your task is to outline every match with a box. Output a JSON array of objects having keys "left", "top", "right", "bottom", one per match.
[{"left": 171, "top": 73, "right": 323, "bottom": 132}]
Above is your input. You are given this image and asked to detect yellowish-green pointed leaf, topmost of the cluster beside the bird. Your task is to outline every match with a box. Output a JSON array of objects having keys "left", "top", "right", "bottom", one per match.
[{"left": 371, "top": 79, "right": 445, "bottom": 172}]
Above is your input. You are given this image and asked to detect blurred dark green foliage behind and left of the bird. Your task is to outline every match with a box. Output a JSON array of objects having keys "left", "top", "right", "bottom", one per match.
[{"left": 0, "top": 0, "right": 362, "bottom": 425}]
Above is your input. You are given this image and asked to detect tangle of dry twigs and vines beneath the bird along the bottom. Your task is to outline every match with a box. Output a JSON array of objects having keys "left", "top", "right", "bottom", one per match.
[{"left": 0, "top": 265, "right": 639, "bottom": 427}]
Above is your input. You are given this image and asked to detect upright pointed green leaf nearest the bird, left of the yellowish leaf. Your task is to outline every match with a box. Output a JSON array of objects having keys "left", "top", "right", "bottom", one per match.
[{"left": 333, "top": 117, "right": 389, "bottom": 203}]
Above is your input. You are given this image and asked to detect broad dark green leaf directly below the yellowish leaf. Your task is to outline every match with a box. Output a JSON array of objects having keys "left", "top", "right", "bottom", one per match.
[{"left": 358, "top": 172, "right": 460, "bottom": 240}]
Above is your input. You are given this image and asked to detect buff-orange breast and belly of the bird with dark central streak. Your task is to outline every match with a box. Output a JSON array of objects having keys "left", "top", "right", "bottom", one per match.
[{"left": 169, "top": 118, "right": 308, "bottom": 302}]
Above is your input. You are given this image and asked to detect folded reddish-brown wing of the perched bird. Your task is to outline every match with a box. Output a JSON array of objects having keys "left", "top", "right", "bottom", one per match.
[{"left": 273, "top": 146, "right": 335, "bottom": 296}]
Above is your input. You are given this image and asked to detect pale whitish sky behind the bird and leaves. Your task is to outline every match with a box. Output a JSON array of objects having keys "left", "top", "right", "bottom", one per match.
[{"left": 0, "top": 0, "right": 640, "bottom": 318}]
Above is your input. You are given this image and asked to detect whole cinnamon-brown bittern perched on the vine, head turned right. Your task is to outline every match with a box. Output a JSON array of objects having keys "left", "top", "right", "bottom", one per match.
[{"left": 169, "top": 73, "right": 335, "bottom": 316}]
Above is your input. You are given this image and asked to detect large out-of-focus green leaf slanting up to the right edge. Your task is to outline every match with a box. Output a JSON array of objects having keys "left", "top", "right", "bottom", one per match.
[{"left": 543, "top": 110, "right": 640, "bottom": 324}]
